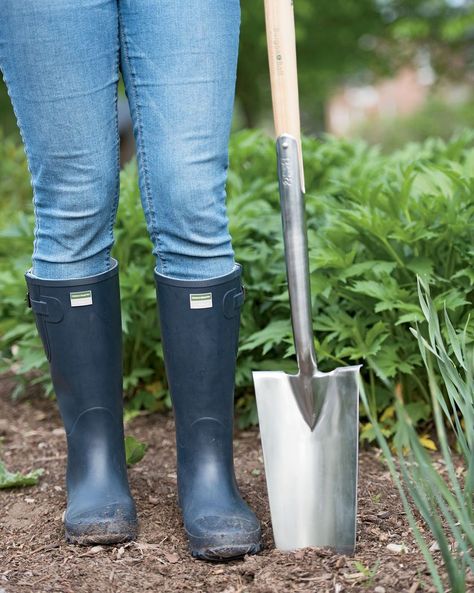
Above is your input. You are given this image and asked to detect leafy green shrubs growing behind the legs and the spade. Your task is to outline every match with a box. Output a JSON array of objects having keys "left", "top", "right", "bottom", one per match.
[{"left": 0, "top": 131, "right": 474, "bottom": 440}]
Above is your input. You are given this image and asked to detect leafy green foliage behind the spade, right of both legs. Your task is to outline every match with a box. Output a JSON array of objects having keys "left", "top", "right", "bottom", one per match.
[{"left": 229, "top": 132, "right": 474, "bottom": 440}]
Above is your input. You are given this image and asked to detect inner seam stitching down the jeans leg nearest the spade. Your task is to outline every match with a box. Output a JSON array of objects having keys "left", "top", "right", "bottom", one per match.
[{"left": 118, "top": 6, "right": 166, "bottom": 273}]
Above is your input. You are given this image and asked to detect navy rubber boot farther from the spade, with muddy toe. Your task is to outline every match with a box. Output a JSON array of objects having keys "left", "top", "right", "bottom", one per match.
[{"left": 25, "top": 259, "right": 137, "bottom": 545}]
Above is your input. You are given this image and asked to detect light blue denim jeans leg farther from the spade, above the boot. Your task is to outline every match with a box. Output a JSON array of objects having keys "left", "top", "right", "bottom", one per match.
[{"left": 0, "top": 0, "right": 119, "bottom": 279}]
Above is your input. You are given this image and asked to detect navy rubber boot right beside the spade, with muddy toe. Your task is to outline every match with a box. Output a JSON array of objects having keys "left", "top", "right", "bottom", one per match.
[{"left": 155, "top": 265, "right": 261, "bottom": 560}]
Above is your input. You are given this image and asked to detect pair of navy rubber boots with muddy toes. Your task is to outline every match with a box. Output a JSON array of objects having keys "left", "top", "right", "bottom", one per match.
[{"left": 25, "top": 259, "right": 261, "bottom": 560}]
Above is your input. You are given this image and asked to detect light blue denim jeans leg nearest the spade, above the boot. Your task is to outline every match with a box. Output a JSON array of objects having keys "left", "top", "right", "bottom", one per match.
[{"left": 118, "top": 0, "right": 240, "bottom": 280}]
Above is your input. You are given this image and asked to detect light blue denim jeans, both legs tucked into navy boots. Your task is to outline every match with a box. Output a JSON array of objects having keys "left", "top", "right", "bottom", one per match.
[{"left": 0, "top": 0, "right": 240, "bottom": 279}]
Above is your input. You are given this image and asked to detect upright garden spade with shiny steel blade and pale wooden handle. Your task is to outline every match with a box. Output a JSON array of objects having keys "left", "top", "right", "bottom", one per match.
[{"left": 253, "top": 0, "right": 360, "bottom": 554}]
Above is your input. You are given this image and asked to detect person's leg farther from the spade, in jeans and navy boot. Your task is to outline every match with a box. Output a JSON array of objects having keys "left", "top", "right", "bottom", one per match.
[{"left": 0, "top": 0, "right": 137, "bottom": 544}]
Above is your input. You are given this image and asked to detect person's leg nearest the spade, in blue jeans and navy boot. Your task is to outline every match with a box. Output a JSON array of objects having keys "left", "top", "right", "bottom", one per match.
[{"left": 119, "top": 0, "right": 261, "bottom": 560}]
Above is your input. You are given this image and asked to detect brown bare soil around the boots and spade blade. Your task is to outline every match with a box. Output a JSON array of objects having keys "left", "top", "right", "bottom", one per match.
[{"left": 0, "top": 380, "right": 452, "bottom": 593}]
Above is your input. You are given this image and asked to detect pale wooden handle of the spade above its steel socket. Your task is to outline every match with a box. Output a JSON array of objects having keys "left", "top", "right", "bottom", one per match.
[{"left": 265, "top": 0, "right": 304, "bottom": 192}]
